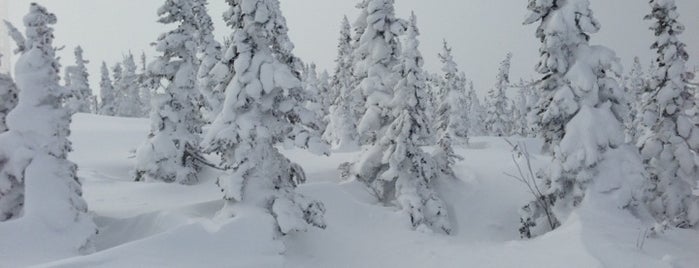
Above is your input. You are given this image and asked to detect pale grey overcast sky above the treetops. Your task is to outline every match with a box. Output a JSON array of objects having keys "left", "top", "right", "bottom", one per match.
[{"left": 0, "top": 0, "right": 699, "bottom": 96}]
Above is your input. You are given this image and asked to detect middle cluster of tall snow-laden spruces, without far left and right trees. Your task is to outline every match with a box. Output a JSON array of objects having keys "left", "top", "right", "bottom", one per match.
[{"left": 133, "top": 0, "right": 470, "bottom": 234}]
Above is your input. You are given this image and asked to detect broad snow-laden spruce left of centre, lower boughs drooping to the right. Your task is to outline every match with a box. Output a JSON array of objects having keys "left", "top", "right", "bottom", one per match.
[{"left": 202, "top": 0, "right": 329, "bottom": 234}]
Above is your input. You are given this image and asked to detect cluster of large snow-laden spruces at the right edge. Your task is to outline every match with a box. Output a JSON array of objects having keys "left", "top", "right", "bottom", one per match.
[{"left": 520, "top": 0, "right": 699, "bottom": 237}]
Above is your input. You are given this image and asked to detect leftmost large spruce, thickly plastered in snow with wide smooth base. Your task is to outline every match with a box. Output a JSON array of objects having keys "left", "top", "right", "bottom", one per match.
[{"left": 0, "top": 3, "right": 97, "bottom": 253}]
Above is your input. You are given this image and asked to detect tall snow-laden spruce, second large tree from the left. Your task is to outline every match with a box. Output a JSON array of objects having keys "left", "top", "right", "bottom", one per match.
[{"left": 135, "top": 0, "right": 204, "bottom": 184}]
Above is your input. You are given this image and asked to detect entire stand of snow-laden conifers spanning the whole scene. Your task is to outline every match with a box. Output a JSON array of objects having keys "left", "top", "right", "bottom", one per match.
[{"left": 0, "top": 0, "right": 699, "bottom": 256}]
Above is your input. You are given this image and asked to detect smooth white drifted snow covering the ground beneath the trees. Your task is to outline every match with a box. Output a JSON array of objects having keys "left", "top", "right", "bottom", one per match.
[{"left": 5, "top": 115, "right": 699, "bottom": 268}]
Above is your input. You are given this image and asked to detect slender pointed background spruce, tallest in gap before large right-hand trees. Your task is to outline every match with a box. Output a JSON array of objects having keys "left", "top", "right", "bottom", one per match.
[{"left": 485, "top": 53, "right": 512, "bottom": 137}]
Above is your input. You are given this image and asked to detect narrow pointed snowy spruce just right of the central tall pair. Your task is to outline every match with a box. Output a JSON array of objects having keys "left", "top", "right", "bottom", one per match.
[{"left": 434, "top": 41, "right": 469, "bottom": 142}]
